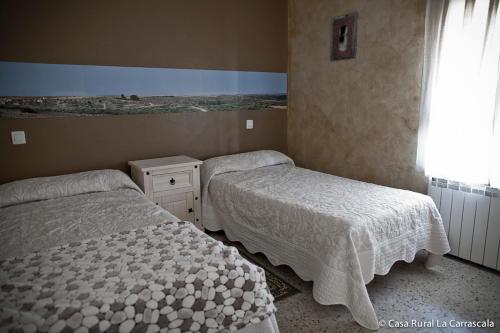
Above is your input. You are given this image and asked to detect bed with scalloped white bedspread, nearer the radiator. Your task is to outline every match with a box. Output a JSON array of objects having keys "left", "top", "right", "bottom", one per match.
[{"left": 202, "top": 151, "right": 450, "bottom": 329}]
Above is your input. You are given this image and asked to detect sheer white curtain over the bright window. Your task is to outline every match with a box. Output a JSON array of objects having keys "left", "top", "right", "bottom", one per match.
[{"left": 417, "top": 0, "right": 500, "bottom": 187}]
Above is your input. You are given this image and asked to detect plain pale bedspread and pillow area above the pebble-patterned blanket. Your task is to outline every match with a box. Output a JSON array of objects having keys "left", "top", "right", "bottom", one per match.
[{"left": 0, "top": 170, "right": 179, "bottom": 259}]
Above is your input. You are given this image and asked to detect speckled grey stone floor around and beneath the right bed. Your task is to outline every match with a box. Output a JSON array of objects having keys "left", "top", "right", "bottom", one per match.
[{"left": 209, "top": 233, "right": 500, "bottom": 333}]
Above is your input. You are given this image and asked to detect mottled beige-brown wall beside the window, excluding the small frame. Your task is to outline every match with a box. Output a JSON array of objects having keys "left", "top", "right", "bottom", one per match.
[{"left": 288, "top": 0, "right": 426, "bottom": 192}]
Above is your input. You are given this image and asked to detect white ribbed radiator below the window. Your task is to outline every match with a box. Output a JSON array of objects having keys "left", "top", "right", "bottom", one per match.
[{"left": 428, "top": 178, "right": 500, "bottom": 270}]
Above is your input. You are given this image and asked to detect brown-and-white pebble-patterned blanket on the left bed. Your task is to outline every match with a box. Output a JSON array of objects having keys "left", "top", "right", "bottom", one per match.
[{"left": 0, "top": 222, "right": 276, "bottom": 333}]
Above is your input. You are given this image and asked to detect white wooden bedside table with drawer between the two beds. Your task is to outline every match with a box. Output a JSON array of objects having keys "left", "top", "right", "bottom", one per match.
[{"left": 128, "top": 156, "right": 203, "bottom": 230}]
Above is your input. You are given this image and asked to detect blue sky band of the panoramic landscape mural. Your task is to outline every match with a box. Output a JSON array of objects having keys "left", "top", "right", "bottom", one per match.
[{"left": 0, "top": 61, "right": 287, "bottom": 96}]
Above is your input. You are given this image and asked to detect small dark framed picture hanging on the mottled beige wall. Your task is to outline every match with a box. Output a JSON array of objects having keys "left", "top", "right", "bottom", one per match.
[{"left": 331, "top": 13, "right": 358, "bottom": 61}]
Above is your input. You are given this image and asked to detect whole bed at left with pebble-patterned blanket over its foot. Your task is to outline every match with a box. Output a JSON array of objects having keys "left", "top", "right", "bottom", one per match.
[{"left": 0, "top": 170, "right": 278, "bottom": 333}]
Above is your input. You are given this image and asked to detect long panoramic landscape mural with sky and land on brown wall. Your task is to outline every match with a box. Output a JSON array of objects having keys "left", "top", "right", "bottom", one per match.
[{"left": 0, "top": 62, "right": 287, "bottom": 118}]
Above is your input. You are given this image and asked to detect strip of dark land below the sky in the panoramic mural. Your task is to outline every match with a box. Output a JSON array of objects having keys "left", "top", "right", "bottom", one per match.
[{"left": 0, "top": 94, "right": 287, "bottom": 118}]
